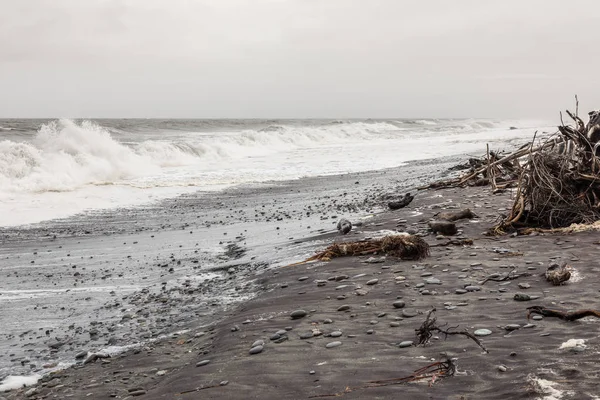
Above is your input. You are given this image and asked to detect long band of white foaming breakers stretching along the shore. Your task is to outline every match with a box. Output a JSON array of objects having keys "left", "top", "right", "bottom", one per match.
[{"left": 0, "top": 119, "right": 532, "bottom": 193}]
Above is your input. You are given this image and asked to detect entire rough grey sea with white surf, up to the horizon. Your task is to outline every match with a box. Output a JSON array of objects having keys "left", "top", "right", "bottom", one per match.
[{"left": 0, "top": 119, "right": 549, "bottom": 226}]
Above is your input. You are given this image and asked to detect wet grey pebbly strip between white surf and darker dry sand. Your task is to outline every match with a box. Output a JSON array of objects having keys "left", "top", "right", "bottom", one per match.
[{"left": 0, "top": 155, "right": 462, "bottom": 390}]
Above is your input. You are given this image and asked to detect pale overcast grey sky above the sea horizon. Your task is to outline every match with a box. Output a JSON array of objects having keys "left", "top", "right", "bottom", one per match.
[{"left": 0, "top": 0, "right": 600, "bottom": 118}]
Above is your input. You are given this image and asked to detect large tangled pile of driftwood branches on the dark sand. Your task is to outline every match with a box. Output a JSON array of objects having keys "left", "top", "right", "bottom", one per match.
[{"left": 428, "top": 103, "right": 600, "bottom": 235}]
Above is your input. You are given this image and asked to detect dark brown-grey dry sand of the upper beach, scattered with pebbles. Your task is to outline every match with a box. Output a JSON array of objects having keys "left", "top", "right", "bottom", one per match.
[{"left": 0, "top": 183, "right": 600, "bottom": 399}]
